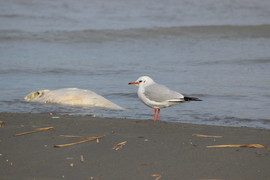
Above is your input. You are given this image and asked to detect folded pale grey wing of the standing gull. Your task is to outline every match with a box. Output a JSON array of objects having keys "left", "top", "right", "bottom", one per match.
[{"left": 144, "top": 84, "right": 184, "bottom": 102}]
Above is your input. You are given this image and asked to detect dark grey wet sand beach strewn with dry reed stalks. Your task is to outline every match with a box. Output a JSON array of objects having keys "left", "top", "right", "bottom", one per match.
[{"left": 0, "top": 113, "right": 270, "bottom": 180}]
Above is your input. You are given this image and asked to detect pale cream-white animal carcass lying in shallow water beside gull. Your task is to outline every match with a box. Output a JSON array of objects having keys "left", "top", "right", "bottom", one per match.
[{"left": 24, "top": 88, "right": 123, "bottom": 109}]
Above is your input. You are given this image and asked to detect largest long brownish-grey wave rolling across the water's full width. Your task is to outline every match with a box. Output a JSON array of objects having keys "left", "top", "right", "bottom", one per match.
[{"left": 0, "top": 25, "right": 270, "bottom": 43}]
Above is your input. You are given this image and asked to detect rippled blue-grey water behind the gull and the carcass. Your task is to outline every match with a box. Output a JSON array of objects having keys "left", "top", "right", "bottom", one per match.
[{"left": 0, "top": 0, "right": 270, "bottom": 129}]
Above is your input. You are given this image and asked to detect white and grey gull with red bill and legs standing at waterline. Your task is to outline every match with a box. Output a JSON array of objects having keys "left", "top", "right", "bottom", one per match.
[{"left": 128, "top": 76, "right": 202, "bottom": 121}]
